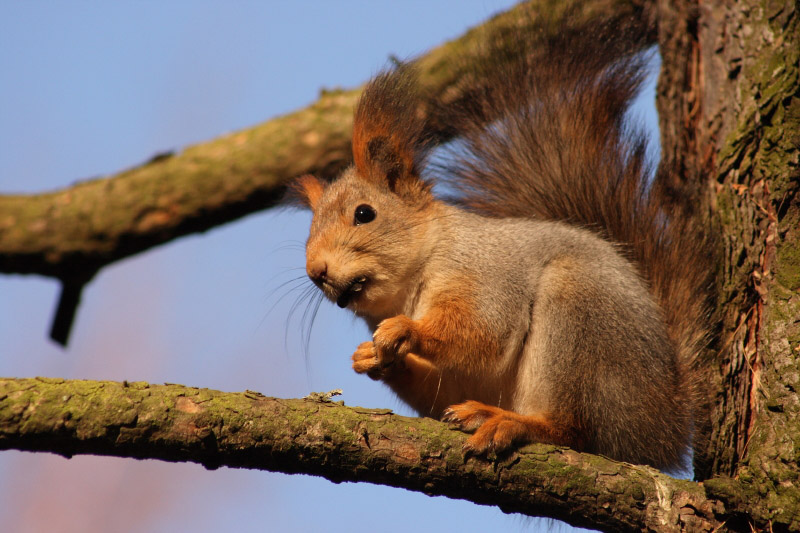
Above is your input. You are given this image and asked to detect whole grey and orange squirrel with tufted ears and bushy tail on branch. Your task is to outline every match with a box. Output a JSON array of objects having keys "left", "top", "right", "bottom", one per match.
[{"left": 293, "top": 19, "right": 710, "bottom": 469}]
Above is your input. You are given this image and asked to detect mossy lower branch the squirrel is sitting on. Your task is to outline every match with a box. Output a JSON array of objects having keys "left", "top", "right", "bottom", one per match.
[{"left": 0, "top": 378, "right": 726, "bottom": 531}]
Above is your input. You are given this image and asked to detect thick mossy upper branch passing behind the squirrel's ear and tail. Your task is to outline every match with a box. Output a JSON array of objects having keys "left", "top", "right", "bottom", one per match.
[{"left": 0, "top": 0, "right": 654, "bottom": 280}]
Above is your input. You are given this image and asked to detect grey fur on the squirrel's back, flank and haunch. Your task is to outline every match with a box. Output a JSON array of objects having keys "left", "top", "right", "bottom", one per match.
[{"left": 422, "top": 208, "right": 689, "bottom": 465}]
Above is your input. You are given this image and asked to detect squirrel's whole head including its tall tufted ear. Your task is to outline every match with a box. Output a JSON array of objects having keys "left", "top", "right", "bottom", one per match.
[{"left": 293, "top": 65, "right": 439, "bottom": 319}]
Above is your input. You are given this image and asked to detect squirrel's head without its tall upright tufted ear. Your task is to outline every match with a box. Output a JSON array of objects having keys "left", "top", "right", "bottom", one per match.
[{"left": 294, "top": 160, "right": 437, "bottom": 319}]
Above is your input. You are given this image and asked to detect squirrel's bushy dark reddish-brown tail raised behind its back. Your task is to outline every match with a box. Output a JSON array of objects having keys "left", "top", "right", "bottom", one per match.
[{"left": 434, "top": 20, "right": 712, "bottom": 474}]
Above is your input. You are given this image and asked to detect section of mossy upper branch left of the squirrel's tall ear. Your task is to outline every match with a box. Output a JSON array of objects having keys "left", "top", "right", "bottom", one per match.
[{"left": 0, "top": 87, "right": 358, "bottom": 277}]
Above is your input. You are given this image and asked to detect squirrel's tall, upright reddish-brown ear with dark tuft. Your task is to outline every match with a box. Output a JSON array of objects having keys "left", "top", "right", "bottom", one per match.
[{"left": 353, "top": 65, "right": 429, "bottom": 195}]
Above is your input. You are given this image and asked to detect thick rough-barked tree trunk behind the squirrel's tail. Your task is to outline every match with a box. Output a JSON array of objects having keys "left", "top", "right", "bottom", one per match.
[{"left": 659, "top": 0, "right": 800, "bottom": 530}]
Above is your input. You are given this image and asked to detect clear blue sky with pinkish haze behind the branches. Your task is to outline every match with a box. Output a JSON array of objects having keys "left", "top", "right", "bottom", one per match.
[{"left": 0, "top": 0, "right": 653, "bottom": 533}]
